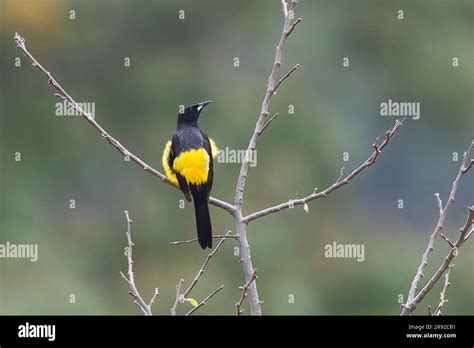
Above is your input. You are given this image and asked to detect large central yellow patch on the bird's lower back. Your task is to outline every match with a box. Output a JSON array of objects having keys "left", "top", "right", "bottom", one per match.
[{"left": 173, "top": 148, "right": 209, "bottom": 185}]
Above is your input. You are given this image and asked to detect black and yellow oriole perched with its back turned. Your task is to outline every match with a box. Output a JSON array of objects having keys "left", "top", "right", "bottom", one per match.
[{"left": 162, "top": 101, "right": 217, "bottom": 249}]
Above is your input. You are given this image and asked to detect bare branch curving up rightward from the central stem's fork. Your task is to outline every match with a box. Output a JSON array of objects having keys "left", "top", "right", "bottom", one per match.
[{"left": 244, "top": 120, "right": 403, "bottom": 223}]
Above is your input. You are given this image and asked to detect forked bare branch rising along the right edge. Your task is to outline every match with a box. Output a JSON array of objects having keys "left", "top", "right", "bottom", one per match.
[{"left": 401, "top": 141, "right": 474, "bottom": 315}]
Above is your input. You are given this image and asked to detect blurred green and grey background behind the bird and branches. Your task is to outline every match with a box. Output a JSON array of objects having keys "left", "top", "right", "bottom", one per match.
[{"left": 0, "top": 0, "right": 474, "bottom": 314}]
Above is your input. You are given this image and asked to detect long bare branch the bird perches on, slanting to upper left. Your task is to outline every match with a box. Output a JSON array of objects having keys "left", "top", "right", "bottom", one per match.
[{"left": 14, "top": 33, "right": 234, "bottom": 213}]
